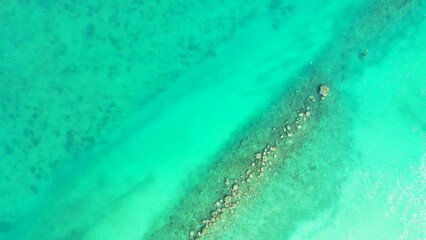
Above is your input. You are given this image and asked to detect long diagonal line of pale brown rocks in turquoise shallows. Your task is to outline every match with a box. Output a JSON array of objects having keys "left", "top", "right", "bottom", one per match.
[{"left": 189, "top": 84, "right": 329, "bottom": 239}]
